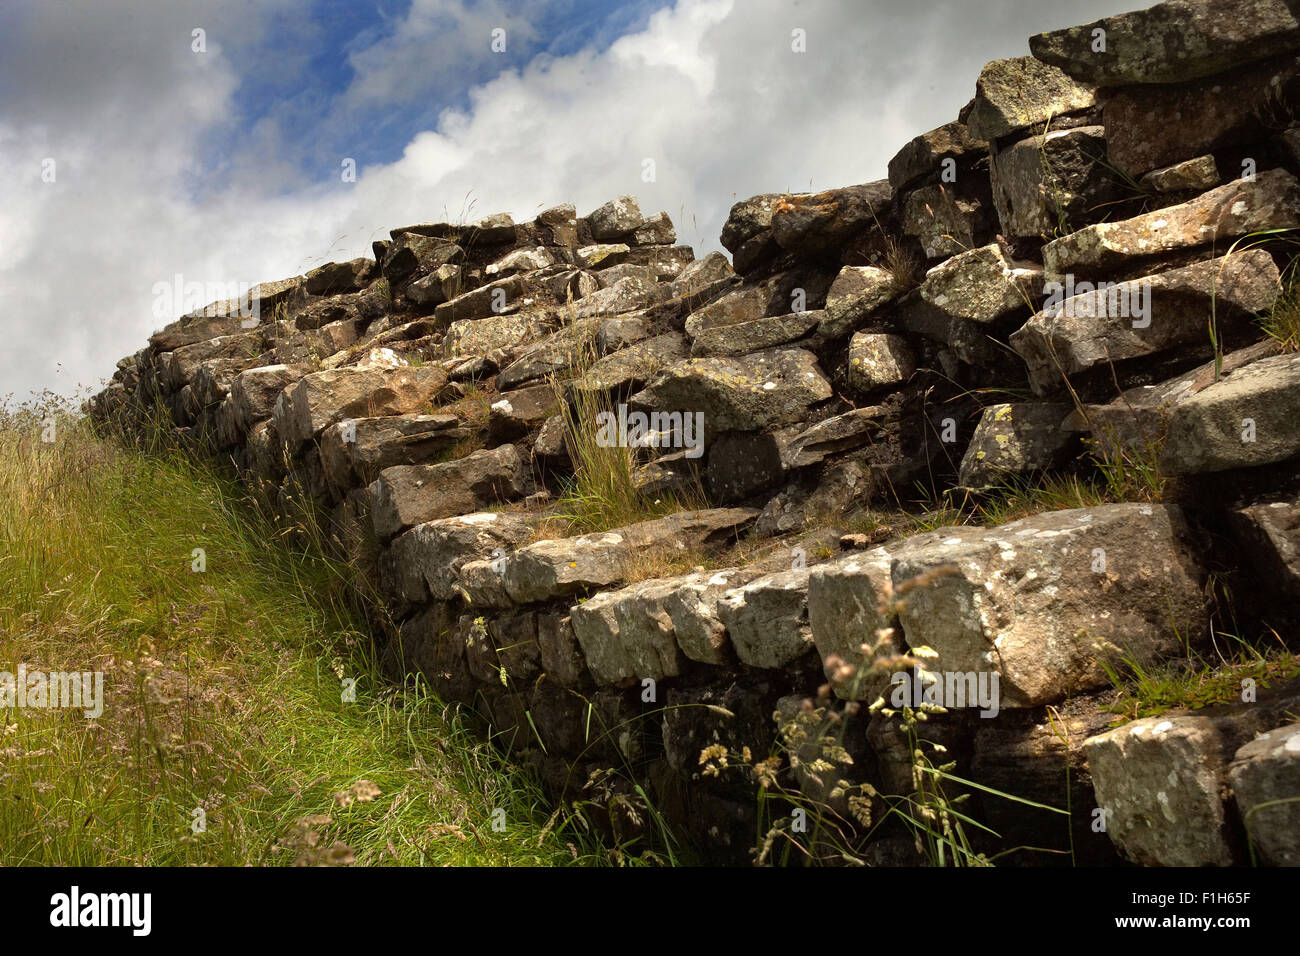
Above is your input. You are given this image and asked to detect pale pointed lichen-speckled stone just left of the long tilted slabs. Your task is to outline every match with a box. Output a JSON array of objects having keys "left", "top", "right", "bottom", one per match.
[{"left": 920, "top": 242, "right": 1043, "bottom": 323}]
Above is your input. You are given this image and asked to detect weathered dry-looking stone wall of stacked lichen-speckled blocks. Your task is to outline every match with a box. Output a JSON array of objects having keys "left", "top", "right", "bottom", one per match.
[{"left": 96, "top": 0, "right": 1300, "bottom": 865}]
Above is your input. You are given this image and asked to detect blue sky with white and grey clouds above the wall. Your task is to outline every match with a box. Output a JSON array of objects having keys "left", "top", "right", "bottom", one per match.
[{"left": 0, "top": 0, "right": 1141, "bottom": 402}]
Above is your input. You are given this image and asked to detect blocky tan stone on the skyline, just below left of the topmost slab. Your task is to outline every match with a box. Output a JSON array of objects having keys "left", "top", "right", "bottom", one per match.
[{"left": 966, "top": 56, "right": 1097, "bottom": 140}]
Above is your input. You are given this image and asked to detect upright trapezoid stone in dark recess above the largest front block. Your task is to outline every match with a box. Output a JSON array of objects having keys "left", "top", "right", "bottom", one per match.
[{"left": 957, "top": 403, "right": 1071, "bottom": 490}]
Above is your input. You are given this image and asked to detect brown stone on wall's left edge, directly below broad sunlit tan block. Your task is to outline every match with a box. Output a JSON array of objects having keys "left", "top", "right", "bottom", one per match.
[{"left": 320, "top": 415, "right": 471, "bottom": 488}]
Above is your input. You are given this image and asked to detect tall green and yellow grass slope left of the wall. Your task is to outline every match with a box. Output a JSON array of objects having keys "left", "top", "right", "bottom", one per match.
[{"left": 0, "top": 408, "right": 608, "bottom": 865}]
